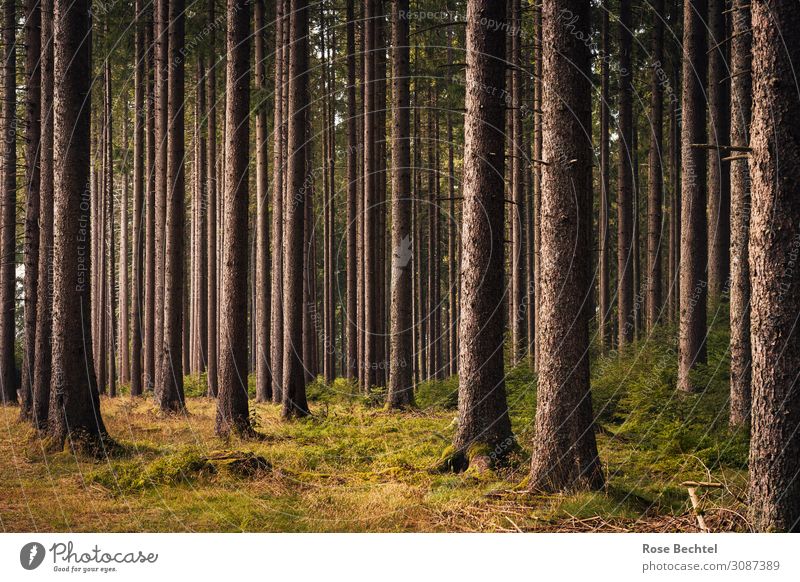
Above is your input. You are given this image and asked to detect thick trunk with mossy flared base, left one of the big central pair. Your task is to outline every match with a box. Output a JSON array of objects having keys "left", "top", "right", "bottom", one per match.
[{"left": 453, "top": 0, "right": 513, "bottom": 469}]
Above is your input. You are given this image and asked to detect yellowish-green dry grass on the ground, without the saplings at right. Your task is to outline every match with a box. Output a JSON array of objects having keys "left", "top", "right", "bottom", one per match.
[{"left": 0, "top": 396, "right": 746, "bottom": 532}]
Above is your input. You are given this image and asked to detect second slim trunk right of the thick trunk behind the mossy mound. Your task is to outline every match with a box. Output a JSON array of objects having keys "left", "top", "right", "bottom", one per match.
[{"left": 271, "top": 0, "right": 289, "bottom": 403}]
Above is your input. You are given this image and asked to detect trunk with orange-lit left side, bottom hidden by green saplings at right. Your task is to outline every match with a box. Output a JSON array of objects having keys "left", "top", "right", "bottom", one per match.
[{"left": 678, "top": 0, "right": 708, "bottom": 392}]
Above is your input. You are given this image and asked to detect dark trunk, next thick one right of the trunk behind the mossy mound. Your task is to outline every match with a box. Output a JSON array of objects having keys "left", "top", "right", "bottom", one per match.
[{"left": 282, "top": 0, "right": 310, "bottom": 418}]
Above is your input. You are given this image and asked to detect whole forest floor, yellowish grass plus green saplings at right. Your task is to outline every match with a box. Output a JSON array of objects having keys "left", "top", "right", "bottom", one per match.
[{"left": 0, "top": 325, "right": 749, "bottom": 532}]
